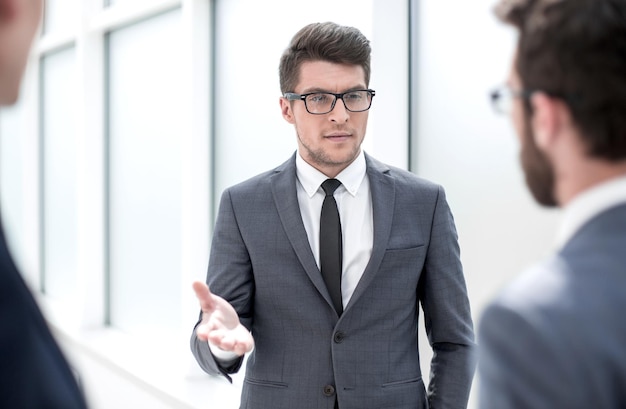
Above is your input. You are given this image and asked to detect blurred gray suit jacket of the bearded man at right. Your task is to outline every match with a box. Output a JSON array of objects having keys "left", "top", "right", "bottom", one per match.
[{"left": 479, "top": 205, "right": 626, "bottom": 409}]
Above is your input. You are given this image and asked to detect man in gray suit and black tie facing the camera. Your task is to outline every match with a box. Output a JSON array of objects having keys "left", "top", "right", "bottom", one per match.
[{"left": 191, "top": 23, "right": 475, "bottom": 409}]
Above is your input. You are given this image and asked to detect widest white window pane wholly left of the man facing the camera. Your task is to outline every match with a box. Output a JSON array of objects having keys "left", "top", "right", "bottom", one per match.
[{"left": 108, "top": 10, "right": 183, "bottom": 332}]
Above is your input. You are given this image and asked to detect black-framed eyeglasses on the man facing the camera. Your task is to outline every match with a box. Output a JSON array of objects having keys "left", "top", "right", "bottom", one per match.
[{"left": 284, "top": 89, "right": 376, "bottom": 115}]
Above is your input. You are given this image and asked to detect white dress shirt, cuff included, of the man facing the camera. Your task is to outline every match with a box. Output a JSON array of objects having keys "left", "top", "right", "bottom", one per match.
[{"left": 209, "top": 151, "right": 374, "bottom": 363}]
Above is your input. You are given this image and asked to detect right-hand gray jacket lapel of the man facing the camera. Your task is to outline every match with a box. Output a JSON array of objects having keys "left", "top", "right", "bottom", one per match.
[{"left": 346, "top": 154, "right": 396, "bottom": 311}]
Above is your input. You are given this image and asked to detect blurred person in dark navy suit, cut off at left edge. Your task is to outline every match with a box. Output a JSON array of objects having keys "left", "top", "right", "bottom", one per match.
[{"left": 0, "top": 0, "right": 86, "bottom": 409}]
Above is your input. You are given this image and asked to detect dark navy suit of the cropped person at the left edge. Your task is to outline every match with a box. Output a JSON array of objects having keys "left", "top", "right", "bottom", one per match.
[{"left": 0, "top": 227, "right": 86, "bottom": 409}]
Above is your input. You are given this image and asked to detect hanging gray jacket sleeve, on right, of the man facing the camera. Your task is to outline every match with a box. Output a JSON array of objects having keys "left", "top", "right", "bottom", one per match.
[{"left": 418, "top": 187, "right": 476, "bottom": 409}]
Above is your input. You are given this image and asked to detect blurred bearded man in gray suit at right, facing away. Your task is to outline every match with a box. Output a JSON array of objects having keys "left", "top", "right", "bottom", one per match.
[{"left": 478, "top": 0, "right": 626, "bottom": 409}]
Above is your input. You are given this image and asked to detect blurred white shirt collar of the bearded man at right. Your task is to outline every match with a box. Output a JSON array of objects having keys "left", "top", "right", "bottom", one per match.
[{"left": 557, "top": 175, "right": 626, "bottom": 248}]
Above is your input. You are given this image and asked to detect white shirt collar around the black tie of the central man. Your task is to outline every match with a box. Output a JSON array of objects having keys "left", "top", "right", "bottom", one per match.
[{"left": 296, "top": 150, "right": 366, "bottom": 197}]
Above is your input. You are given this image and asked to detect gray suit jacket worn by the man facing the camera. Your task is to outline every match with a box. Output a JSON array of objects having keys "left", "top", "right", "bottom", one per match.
[{"left": 191, "top": 155, "right": 475, "bottom": 409}]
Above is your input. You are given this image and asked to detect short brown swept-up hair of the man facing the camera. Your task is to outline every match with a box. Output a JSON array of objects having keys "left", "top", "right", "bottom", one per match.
[{"left": 278, "top": 22, "right": 372, "bottom": 94}]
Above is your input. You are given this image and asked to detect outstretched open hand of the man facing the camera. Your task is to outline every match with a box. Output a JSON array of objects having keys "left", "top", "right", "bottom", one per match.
[{"left": 193, "top": 281, "right": 254, "bottom": 356}]
